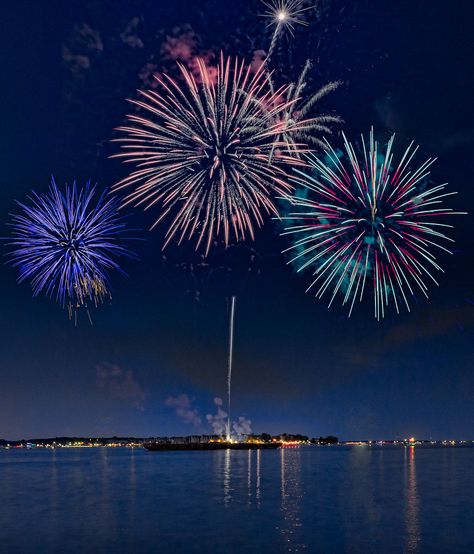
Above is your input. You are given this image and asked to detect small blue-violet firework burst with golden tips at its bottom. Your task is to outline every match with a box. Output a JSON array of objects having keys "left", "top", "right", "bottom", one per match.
[{"left": 10, "top": 179, "right": 130, "bottom": 316}]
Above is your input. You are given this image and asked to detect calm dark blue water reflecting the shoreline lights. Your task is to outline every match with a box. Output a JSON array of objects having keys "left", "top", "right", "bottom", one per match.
[{"left": 0, "top": 447, "right": 474, "bottom": 554}]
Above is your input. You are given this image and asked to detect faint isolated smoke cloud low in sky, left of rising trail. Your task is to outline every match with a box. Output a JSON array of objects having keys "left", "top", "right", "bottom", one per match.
[{"left": 96, "top": 363, "right": 145, "bottom": 411}]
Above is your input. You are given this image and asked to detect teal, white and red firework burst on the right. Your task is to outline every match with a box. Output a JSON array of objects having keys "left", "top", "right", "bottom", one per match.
[{"left": 283, "top": 130, "right": 460, "bottom": 319}]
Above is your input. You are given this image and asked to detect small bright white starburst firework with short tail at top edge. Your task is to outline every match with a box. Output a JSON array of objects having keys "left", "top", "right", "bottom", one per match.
[{"left": 262, "top": 0, "right": 311, "bottom": 63}]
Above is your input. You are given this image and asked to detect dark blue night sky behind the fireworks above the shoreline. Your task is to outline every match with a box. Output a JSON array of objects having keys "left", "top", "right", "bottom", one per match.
[{"left": 0, "top": 0, "right": 474, "bottom": 439}]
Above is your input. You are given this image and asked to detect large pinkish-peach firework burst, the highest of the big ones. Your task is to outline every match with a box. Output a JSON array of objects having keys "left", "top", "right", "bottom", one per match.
[{"left": 114, "top": 52, "right": 304, "bottom": 254}]
